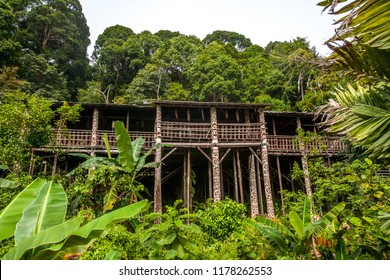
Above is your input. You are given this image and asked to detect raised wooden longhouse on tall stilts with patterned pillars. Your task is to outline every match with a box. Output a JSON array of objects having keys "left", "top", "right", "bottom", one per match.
[{"left": 34, "top": 101, "right": 345, "bottom": 216}]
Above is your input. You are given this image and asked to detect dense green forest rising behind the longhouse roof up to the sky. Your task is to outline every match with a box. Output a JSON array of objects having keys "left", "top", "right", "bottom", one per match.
[{"left": 0, "top": 1, "right": 348, "bottom": 111}]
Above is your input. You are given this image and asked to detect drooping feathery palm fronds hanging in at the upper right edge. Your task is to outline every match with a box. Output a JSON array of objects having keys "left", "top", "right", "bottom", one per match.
[{"left": 318, "top": 0, "right": 390, "bottom": 159}]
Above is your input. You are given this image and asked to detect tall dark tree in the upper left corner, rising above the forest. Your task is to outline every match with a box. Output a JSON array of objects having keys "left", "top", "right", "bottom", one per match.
[{"left": 9, "top": 0, "right": 90, "bottom": 98}]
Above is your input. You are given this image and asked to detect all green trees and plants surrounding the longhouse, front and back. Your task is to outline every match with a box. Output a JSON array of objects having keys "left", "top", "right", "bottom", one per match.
[{"left": 0, "top": 0, "right": 390, "bottom": 259}]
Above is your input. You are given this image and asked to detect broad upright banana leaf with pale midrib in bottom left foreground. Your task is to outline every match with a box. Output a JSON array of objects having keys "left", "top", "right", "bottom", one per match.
[{"left": 15, "top": 181, "right": 68, "bottom": 244}]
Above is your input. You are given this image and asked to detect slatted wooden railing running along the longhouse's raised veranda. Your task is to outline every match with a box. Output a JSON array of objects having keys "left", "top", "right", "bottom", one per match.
[{"left": 48, "top": 127, "right": 346, "bottom": 154}]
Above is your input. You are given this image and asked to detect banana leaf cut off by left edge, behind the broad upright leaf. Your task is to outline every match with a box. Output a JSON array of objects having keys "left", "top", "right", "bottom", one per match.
[{"left": 0, "top": 178, "right": 46, "bottom": 241}]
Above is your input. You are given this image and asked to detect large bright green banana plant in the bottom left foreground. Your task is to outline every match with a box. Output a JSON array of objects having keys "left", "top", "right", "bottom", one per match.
[{"left": 0, "top": 179, "right": 148, "bottom": 260}]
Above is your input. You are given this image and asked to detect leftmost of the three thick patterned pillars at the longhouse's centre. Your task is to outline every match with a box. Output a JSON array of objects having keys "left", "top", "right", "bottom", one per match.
[{"left": 154, "top": 104, "right": 162, "bottom": 213}]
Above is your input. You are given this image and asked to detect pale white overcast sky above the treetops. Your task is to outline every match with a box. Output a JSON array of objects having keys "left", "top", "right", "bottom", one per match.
[{"left": 79, "top": 0, "right": 335, "bottom": 55}]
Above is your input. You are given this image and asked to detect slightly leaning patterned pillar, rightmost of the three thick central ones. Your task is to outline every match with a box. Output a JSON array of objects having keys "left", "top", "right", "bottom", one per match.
[{"left": 259, "top": 110, "right": 275, "bottom": 217}]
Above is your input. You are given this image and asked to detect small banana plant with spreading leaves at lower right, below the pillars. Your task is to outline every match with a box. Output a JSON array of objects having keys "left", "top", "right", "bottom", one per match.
[{"left": 252, "top": 198, "right": 345, "bottom": 258}]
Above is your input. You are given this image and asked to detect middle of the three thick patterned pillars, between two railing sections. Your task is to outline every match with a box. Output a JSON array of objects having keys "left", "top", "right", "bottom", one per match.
[{"left": 210, "top": 106, "right": 221, "bottom": 202}]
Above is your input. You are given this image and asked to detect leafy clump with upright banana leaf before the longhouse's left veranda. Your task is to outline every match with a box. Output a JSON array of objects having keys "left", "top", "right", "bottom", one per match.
[{"left": 67, "top": 121, "right": 157, "bottom": 215}]
